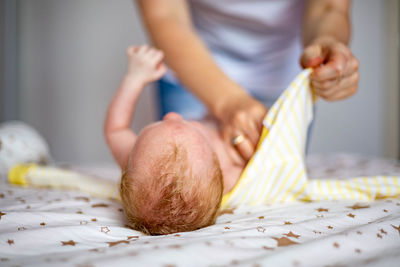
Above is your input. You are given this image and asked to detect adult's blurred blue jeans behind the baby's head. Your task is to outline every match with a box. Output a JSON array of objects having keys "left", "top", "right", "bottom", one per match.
[{"left": 157, "top": 79, "right": 316, "bottom": 154}]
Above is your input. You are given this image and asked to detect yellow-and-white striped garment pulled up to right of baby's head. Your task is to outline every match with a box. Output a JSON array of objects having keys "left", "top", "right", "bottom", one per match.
[{"left": 221, "top": 70, "right": 400, "bottom": 209}]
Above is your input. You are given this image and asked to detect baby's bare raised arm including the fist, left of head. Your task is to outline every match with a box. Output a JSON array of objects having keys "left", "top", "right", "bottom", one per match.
[{"left": 104, "top": 46, "right": 166, "bottom": 169}]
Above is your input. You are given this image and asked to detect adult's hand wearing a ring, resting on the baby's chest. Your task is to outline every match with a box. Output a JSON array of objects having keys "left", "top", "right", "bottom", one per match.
[{"left": 219, "top": 93, "right": 267, "bottom": 165}]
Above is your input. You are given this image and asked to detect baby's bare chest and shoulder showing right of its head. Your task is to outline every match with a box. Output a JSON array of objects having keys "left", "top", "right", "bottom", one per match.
[{"left": 190, "top": 119, "right": 245, "bottom": 194}]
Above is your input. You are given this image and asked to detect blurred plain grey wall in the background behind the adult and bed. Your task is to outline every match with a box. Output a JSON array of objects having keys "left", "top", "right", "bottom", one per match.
[{"left": 0, "top": 0, "right": 400, "bottom": 163}]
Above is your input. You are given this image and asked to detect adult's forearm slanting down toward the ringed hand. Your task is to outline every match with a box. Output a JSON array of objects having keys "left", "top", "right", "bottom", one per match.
[{"left": 141, "top": 18, "right": 246, "bottom": 117}]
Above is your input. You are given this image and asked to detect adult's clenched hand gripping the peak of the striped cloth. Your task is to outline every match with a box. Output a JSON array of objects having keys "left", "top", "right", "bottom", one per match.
[{"left": 300, "top": 37, "right": 359, "bottom": 101}]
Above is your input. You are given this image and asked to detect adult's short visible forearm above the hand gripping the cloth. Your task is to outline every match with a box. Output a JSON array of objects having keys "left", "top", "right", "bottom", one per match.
[{"left": 303, "top": 0, "right": 350, "bottom": 46}]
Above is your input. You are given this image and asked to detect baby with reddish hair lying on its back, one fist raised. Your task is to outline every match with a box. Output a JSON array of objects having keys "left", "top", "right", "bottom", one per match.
[{"left": 104, "top": 46, "right": 244, "bottom": 237}]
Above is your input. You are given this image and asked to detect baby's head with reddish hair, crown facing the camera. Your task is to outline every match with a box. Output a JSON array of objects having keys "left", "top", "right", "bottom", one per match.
[{"left": 121, "top": 113, "right": 223, "bottom": 234}]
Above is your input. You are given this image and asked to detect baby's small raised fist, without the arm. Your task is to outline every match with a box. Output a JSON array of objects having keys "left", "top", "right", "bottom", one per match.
[{"left": 126, "top": 45, "right": 167, "bottom": 85}]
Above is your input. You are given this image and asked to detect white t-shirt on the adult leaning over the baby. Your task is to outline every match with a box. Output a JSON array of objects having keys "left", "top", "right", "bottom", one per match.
[{"left": 162, "top": 0, "right": 303, "bottom": 100}]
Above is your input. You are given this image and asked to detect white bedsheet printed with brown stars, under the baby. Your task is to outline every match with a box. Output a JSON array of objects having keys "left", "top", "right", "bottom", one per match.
[{"left": 0, "top": 155, "right": 400, "bottom": 266}]
